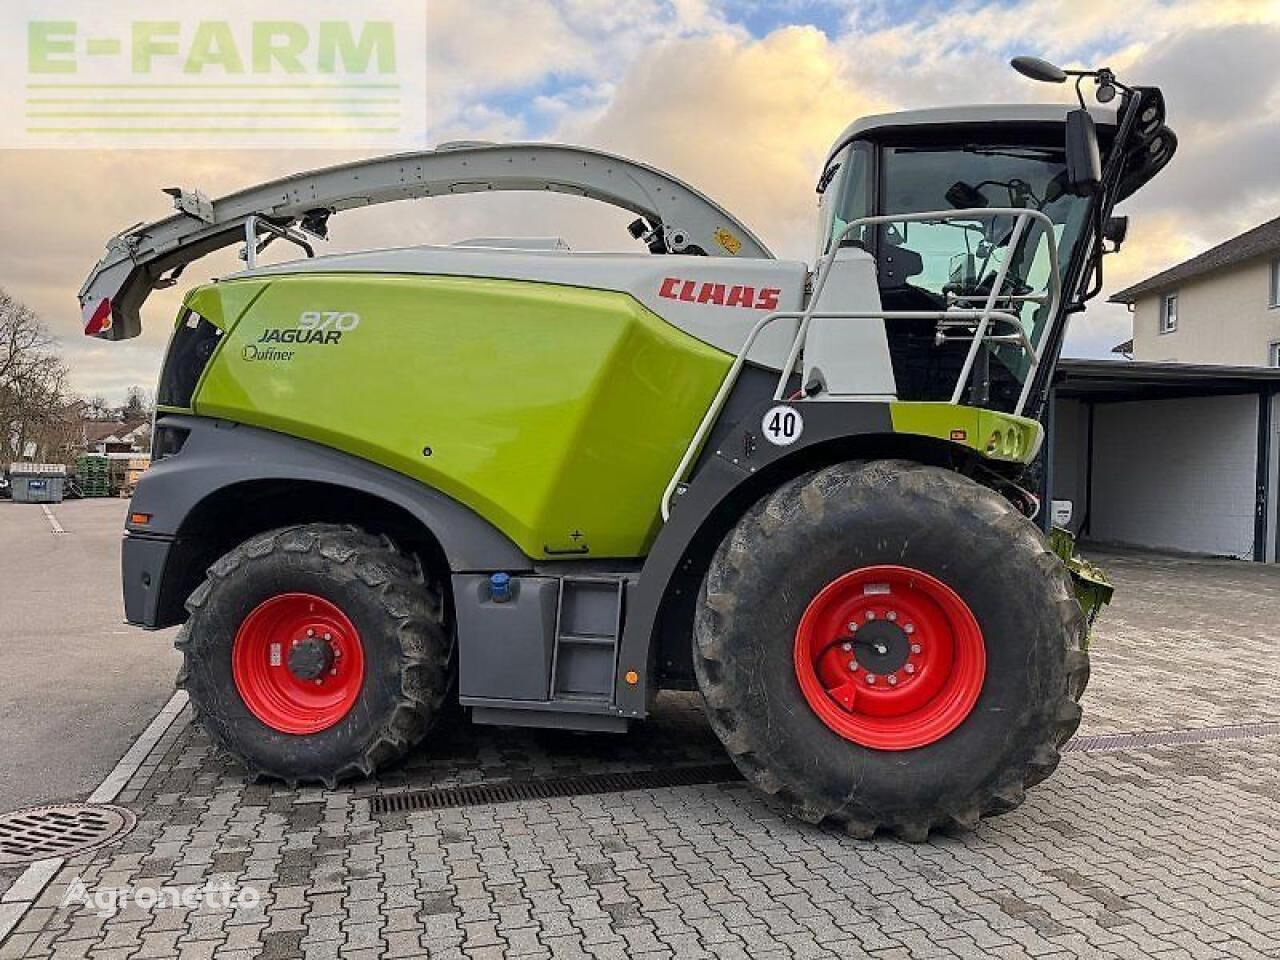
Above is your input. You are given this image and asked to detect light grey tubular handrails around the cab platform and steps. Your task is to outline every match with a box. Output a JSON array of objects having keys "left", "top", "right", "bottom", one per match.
[{"left": 660, "top": 207, "right": 1062, "bottom": 522}]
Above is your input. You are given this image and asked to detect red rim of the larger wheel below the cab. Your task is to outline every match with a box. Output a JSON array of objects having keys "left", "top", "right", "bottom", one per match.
[{"left": 795, "top": 566, "right": 987, "bottom": 750}]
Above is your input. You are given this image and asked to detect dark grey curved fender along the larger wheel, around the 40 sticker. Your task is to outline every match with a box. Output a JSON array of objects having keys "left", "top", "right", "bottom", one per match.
[{"left": 614, "top": 401, "right": 893, "bottom": 717}]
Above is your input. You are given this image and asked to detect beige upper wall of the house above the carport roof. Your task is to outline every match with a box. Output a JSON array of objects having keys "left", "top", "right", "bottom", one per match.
[{"left": 1133, "top": 259, "right": 1280, "bottom": 366}]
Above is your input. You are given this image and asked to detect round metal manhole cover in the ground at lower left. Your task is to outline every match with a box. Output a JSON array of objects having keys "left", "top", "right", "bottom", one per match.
[{"left": 0, "top": 804, "right": 136, "bottom": 867}]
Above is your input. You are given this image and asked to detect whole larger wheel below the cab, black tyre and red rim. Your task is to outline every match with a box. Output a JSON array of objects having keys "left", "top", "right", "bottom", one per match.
[{"left": 694, "top": 461, "right": 1088, "bottom": 841}]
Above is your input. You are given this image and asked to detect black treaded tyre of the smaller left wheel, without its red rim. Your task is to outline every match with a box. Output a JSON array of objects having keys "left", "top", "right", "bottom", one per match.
[{"left": 175, "top": 524, "right": 453, "bottom": 786}]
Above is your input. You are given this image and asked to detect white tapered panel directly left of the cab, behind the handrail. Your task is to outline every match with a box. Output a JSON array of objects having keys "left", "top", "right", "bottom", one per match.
[{"left": 804, "top": 247, "right": 897, "bottom": 399}]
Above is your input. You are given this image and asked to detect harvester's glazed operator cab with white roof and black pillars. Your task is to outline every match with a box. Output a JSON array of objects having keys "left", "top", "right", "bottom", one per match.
[{"left": 818, "top": 90, "right": 1176, "bottom": 412}]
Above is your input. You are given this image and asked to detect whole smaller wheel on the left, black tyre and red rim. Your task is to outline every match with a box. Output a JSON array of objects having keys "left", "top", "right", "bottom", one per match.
[{"left": 175, "top": 524, "right": 453, "bottom": 786}]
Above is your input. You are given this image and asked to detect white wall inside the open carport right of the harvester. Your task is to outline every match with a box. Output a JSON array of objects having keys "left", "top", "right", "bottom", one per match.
[{"left": 1089, "top": 397, "right": 1258, "bottom": 559}]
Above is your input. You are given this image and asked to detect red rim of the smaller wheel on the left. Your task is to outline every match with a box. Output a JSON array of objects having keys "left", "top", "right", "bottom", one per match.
[{"left": 232, "top": 594, "right": 365, "bottom": 733}]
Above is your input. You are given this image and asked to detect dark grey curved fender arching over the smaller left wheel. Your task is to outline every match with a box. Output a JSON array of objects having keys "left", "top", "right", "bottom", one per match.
[{"left": 132, "top": 415, "right": 531, "bottom": 572}]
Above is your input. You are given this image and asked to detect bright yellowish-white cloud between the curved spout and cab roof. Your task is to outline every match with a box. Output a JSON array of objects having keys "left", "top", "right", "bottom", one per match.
[{"left": 558, "top": 27, "right": 884, "bottom": 259}]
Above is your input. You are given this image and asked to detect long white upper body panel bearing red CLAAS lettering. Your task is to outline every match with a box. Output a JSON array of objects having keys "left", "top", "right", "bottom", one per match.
[{"left": 237, "top": 246, "right": 803, "bottom": 370}]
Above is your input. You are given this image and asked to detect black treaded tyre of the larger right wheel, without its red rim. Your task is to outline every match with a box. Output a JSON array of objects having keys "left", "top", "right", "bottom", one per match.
[{"left": 694, "top": 460, "right": 1088, "bottom": 841}]
